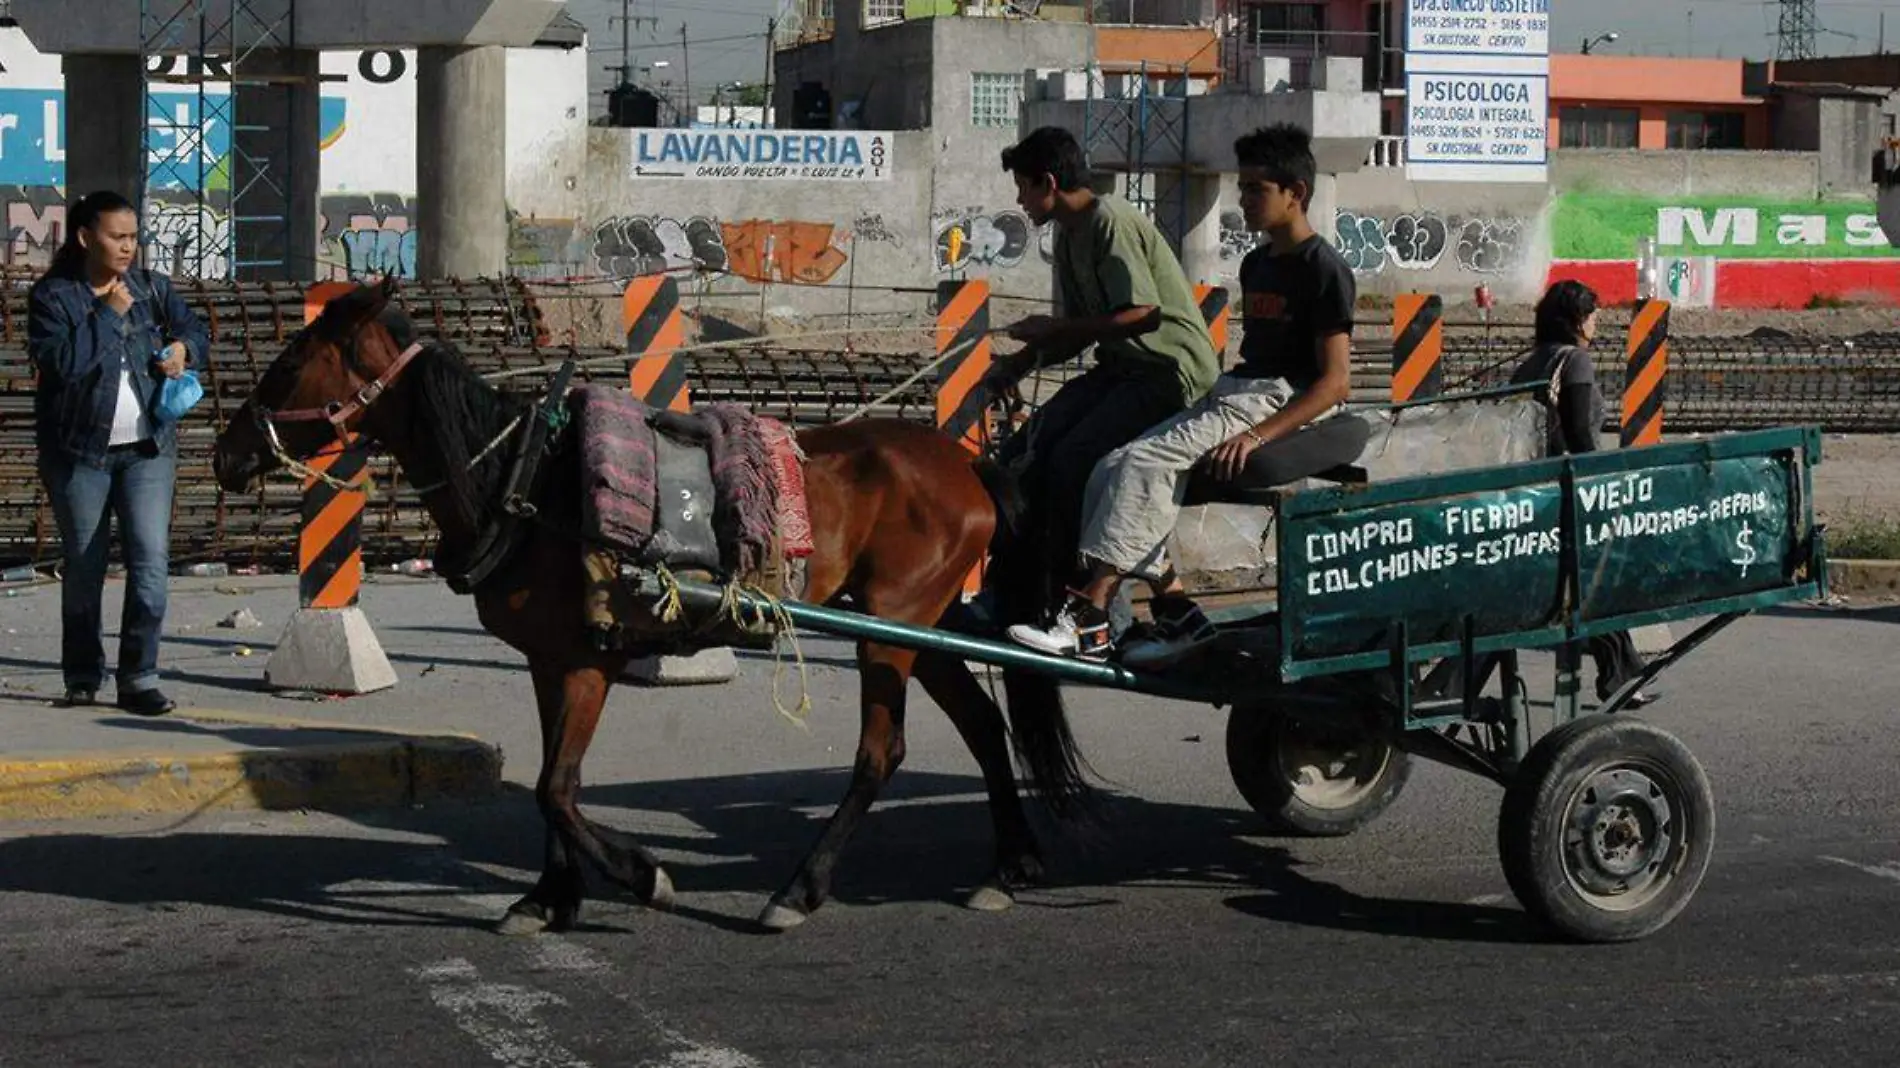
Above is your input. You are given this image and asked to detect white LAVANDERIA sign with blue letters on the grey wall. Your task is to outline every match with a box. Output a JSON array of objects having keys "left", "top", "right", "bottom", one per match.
[{"left": 631, "top": 129, "right": 891, "bottom": 182}]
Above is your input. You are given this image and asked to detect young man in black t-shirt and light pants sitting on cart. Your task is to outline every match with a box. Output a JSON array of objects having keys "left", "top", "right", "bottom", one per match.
[{"left": 1009, "top": 125, "right": 1357, "bottom": 669}]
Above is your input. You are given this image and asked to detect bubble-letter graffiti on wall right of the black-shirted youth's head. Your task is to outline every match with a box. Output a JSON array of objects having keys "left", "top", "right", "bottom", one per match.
[{"left": 1334, "top": 209, "right": 1531, "bottom": 274}]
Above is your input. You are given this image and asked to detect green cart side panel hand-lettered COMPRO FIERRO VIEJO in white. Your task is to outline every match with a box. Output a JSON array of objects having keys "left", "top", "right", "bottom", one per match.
[{"left": 1279, "top": 427, "right": 1809, "bottom": 659}]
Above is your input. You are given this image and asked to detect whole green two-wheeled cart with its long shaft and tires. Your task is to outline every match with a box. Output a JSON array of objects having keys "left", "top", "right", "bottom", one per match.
[{"left": 646, "top": 428, "right": 1826, "bottom": 941}]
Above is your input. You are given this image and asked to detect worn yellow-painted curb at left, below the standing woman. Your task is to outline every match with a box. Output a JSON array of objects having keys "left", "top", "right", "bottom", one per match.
[{"left": 0, "top": 709, "right": 502, "bottom": 819}]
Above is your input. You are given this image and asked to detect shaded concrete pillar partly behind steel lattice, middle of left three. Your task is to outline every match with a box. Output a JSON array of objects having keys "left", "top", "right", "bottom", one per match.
[{"left": 230, "top": 49, "right": 323, "bottom": 281}]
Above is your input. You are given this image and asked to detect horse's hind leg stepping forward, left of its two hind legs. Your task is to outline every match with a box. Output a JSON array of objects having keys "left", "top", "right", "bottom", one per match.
[{"left": 758, "top": 642, "right": 918, "bottom": 931}]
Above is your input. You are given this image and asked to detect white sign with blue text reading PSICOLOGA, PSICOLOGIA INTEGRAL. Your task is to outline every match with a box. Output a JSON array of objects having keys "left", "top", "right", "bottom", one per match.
[{"left": 1406, "top": 72, "right": 1550, "bottom": 163}]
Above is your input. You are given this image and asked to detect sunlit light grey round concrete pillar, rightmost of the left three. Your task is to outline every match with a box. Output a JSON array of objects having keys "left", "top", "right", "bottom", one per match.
[{"left": 416, "top": 46, "right": 507, "bottom": 279}]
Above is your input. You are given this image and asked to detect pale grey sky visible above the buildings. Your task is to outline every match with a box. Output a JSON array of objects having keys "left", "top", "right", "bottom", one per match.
[{"left": 568, "top": 0, "right": 1900, "bottom": 110}]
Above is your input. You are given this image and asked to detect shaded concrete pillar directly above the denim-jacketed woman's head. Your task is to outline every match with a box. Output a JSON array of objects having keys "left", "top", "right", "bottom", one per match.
[{"left": 61, "top": 55, "right": 144, "bottom": 208}]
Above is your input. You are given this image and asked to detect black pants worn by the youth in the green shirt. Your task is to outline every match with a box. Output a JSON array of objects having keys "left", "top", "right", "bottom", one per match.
[{"left": 998, "top": 365, "right": 1188, "bottom": 612}]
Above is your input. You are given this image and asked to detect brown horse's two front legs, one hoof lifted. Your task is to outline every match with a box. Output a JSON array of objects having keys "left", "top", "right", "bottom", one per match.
[{"left": 500, "top": 663, "right": 673, "bottom": 933}]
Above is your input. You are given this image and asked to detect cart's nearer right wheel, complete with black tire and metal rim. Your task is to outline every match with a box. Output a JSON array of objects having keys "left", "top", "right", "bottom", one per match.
[{"left": 1497, "top": 715, "right": 1716, "bottom": 943}]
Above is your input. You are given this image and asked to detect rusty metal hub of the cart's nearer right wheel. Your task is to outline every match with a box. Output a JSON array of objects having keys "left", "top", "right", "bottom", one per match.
[{"left": 1564, "top": 768, "right": 1682, "bottom": 908}]
